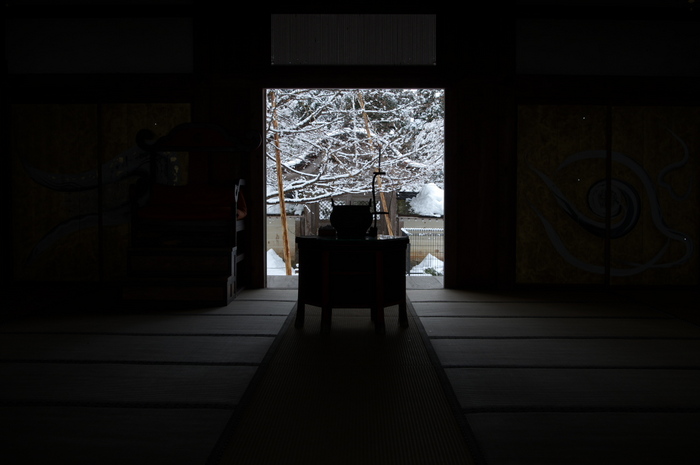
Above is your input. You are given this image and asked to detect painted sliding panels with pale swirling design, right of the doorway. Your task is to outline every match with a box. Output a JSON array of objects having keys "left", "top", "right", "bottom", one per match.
[{"left": 517, "top": 106, "right": 700, "bottom": 284}]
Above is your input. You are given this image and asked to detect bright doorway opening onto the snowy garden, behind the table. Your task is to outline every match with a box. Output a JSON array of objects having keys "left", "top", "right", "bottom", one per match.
[{"left": 265, "top": 88, "right": 445, "bottom": 287}]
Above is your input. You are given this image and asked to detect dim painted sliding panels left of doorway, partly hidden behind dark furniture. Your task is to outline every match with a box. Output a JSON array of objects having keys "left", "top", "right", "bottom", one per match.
[{"left": 12, "top": 104, "right": 190, "bottom": 281}]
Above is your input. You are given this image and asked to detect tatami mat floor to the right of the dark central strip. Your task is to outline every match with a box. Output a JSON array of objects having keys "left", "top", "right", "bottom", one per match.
[{"left": 408, "top": 284, "right": 700, "bottom": 465}]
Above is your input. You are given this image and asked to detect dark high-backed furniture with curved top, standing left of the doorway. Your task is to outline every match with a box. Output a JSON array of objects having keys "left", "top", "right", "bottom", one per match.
[{"left": 123, "top": 123, "right": 261, "bottom": 305}]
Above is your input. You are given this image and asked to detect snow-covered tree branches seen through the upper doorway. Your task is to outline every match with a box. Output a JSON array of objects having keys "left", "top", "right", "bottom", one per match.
[{"left": 266, "top": 89, "right": 444, "bottom": 214}]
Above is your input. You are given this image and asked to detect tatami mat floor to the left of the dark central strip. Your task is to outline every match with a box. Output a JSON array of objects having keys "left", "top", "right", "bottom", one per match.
[{"left": 0, "top": 289, "right": 296, "bottom": 465}]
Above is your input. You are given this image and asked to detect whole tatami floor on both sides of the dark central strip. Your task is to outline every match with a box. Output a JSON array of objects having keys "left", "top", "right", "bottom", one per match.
[{"left": 0, "top": 281, "right": 700, "bottom": 465}]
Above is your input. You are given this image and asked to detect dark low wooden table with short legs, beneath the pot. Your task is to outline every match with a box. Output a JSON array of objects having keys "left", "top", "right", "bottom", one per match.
[{"left": 295, "top": 236, "right": 408, "bottom": 334}]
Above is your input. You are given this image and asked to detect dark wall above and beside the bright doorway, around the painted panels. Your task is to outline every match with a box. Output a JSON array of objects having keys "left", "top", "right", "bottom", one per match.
[{"left": 2, "top": 2, "right": 700, "bottom": 288}]
